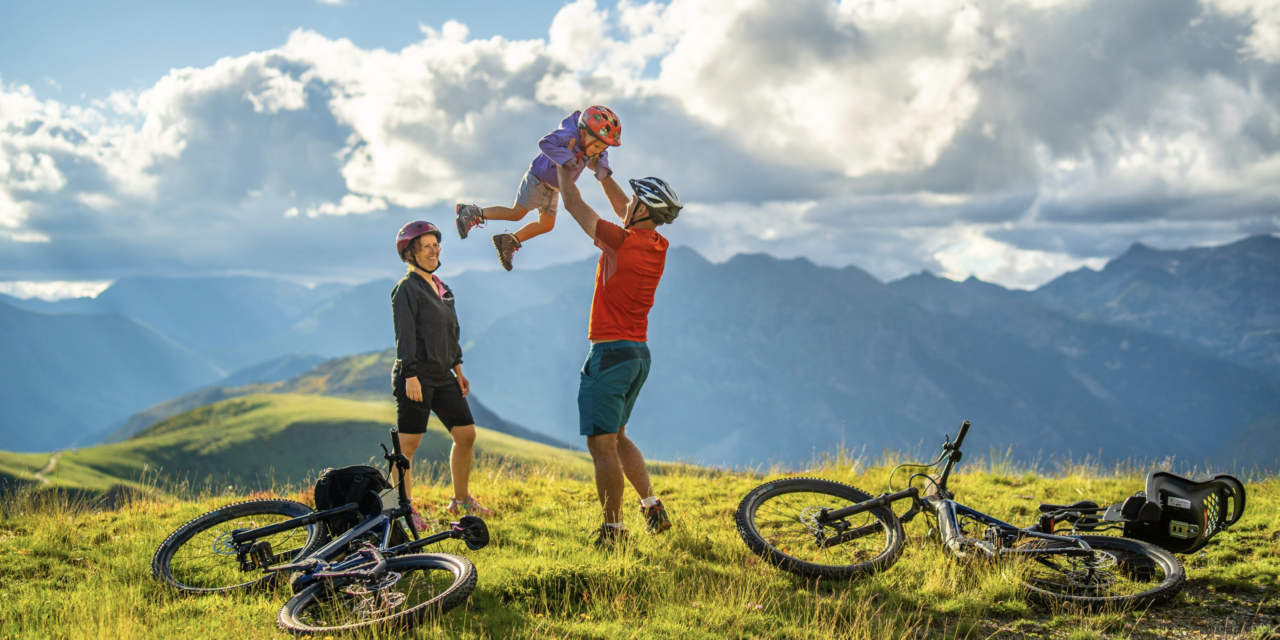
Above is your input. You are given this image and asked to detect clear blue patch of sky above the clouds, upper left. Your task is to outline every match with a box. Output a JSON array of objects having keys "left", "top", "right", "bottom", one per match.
[{"left": 0, "top": 0, "right": 599, "bottom": 101}]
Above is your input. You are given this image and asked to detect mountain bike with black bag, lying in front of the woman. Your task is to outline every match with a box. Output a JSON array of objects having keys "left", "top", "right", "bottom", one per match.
[{"left": 151, "top": 429, "right": 489, "bottom": 634}]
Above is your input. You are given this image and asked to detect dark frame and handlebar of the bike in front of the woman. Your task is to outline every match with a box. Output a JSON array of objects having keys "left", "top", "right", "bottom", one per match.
[{"left": 222, "top": 429, "right": 489, "bottom": 591}]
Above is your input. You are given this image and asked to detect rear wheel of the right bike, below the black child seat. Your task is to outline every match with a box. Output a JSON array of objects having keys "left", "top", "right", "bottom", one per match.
[{"left": 1018, "top": 535, "right": 1187, "bottom": 611}]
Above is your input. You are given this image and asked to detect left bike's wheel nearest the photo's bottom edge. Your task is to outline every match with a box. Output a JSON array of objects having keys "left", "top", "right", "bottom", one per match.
[{"left": 276, "top": 553, "right": 476, "bottom": 635}]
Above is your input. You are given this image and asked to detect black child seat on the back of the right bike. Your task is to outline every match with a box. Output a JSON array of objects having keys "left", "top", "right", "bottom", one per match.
[{"left": 1103, "top": 471, "right": 1244, "bottom": 553}]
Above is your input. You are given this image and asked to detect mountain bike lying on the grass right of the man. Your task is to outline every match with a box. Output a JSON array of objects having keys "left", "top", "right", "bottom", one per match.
[{"left": 737, "top": 421, "right": 1185, "bottom": 609}]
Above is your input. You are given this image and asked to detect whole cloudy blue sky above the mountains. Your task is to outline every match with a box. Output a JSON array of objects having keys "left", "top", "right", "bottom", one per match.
[{"left": 0, "top": 0, "right": 1280, "bottom": 291}]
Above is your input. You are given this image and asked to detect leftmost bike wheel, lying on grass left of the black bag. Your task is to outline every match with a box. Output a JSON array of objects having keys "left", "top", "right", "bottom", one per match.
[{"left": 151, "top": 500, "right": 328, "bottom": 594}]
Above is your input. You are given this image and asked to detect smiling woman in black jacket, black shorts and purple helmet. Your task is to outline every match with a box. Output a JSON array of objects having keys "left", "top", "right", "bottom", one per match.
[{"left": 392, "top": 220, "right": 493, "bottom": 530}]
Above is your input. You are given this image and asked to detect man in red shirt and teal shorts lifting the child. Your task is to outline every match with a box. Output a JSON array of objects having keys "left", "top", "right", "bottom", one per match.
[{"left": 557, "top": 163, "right": 681, "bottom": 547}]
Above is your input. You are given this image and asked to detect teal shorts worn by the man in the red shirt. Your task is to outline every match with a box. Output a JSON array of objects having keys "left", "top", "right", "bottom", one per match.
[{"left": 577, "top": 340, "right": 649, "bottom": 435}]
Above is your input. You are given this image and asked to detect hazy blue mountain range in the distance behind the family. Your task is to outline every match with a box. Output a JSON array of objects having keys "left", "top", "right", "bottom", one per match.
[{"left": 0, "top": 236, "right": 1280, "bottom": 465}]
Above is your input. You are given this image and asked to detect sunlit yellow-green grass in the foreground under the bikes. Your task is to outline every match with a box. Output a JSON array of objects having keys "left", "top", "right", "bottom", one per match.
[{"left": 0, "top": 453, "right": 1280, "bottom": 640}]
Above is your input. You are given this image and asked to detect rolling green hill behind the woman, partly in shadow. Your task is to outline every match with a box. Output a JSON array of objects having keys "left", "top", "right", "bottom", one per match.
[{"left": 11, "top": 394, "right": 589, "bottom": 492}]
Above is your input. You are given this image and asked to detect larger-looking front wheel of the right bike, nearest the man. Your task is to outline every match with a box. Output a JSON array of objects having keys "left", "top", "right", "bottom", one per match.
[{"left": 737, "top": 477, "right": 904, "bottom": 580}]
